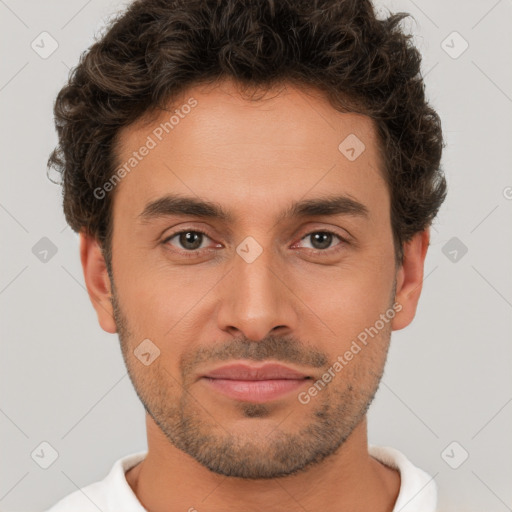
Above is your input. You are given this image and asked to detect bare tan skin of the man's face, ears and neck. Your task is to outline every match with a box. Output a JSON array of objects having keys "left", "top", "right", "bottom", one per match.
[{"left": 80, "top": 81, "right": 429, "bottom": 512}]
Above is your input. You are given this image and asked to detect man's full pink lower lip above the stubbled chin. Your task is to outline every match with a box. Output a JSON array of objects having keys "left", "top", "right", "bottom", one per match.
[{"left": 203, "top": 377, "right": 308, "bottom": 403}]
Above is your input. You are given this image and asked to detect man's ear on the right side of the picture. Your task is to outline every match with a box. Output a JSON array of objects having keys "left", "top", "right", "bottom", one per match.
[{"left": 391, "top": 228, "right": 430, "bottom": 331}]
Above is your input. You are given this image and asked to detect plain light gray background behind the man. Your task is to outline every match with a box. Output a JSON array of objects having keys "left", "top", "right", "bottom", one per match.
[{"left": 0, "top": 0, "right": 512, "bottom": 512}]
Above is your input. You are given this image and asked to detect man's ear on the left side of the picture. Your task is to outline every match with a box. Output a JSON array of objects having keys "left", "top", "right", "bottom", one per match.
[{"left": 80, "top": 230, "right": 117, "bottom": 334}]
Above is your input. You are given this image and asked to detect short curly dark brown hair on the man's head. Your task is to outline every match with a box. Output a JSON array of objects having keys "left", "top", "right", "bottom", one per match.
[{"left": 48, "top": 0, "right": 446, "bottom": 269}]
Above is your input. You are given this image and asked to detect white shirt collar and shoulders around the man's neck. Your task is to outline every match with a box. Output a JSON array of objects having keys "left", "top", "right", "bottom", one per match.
[{"left": 46, "top": 446, "right": 437, "bottom": 512}]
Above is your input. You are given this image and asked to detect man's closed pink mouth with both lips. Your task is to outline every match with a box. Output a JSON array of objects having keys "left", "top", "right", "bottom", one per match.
[{"left": 201, "top": 363, "right": 312, "bottom": 403}]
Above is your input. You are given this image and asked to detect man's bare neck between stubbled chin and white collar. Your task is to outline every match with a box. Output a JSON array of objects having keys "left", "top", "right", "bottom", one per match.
[{"left": 126, "top": 415, "right": 400, "bottom": 512}]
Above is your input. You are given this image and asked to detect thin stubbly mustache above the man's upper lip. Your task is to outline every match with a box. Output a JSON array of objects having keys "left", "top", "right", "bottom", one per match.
[{"left": 180, "top": 335, "right": 328, "bottom": 375}]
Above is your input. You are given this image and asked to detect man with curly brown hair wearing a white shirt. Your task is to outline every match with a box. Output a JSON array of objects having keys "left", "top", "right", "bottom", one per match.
[{"left": 49, "top": 0, "right": 446, "bottom": 512}]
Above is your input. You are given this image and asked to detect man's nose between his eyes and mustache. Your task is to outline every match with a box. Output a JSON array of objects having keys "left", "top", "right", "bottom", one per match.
[{"left": 218, "top": 243, "right": 298, "bottom": 341}]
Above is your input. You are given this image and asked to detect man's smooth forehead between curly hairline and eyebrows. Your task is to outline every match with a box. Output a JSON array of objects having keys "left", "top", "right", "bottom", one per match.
[{"left": 114, "top": 81, "right": 389, "bottom": 222}]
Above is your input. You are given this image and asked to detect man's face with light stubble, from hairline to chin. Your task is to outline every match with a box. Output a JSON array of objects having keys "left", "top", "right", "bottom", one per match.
[{"left": 105, "top": 82, "right": 396, "bottom": 478}]
